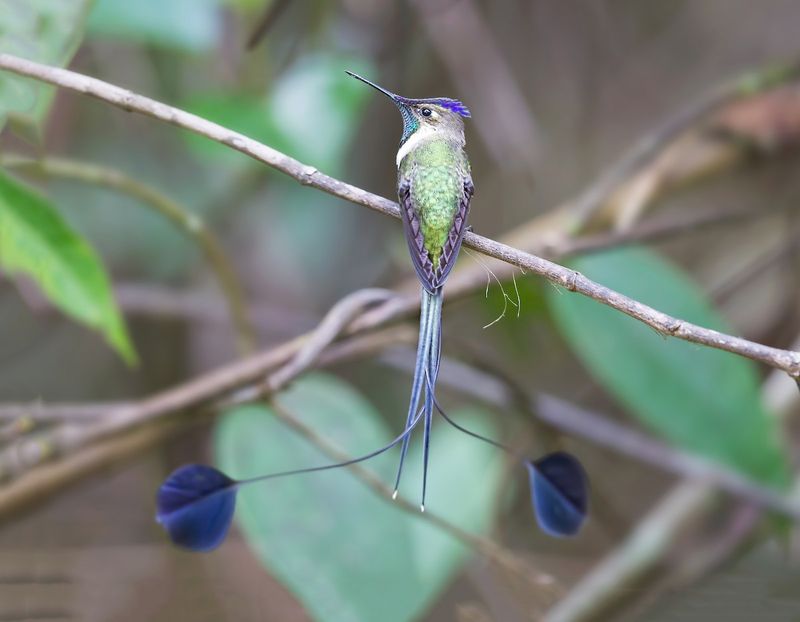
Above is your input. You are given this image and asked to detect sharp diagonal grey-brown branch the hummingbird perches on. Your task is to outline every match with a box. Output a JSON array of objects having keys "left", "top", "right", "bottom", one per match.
[{"left": 0, "top": 54, "right": 800, "bottom": 377}]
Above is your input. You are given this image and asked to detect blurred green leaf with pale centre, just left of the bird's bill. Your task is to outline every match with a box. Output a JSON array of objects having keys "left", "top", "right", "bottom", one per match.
[{"left": 184, "top": 54, "right": 376, "bottom": 175}]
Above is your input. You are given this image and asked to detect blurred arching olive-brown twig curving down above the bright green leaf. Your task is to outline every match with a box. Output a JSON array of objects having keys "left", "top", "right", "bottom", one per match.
[{"left": 0, "top": 155, "right": 257, "bottom": 353}]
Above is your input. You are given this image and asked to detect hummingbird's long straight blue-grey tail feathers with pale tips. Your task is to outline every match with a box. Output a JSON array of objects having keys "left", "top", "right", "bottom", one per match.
[{"left": 394, "top": 287, "right": 442, "bottom": 512}]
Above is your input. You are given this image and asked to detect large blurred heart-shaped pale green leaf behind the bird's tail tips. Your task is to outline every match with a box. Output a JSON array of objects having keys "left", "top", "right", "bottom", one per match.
[{"left": 215, "top": 375, "right": 502, "bottom": 622}]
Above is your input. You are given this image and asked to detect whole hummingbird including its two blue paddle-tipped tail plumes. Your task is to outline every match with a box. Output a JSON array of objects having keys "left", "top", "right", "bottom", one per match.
[{"left": 156, "top": 71, "right": 588, "bottom": 551}]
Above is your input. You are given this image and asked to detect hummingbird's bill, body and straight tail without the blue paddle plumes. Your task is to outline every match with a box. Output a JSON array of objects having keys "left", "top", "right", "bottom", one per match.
[{"left": 347, "top": 71, "right": 475, "bottom": 511}]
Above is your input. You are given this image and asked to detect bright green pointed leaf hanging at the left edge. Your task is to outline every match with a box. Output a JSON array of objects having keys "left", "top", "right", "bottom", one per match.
[{"left": 0, "top": 172, "right": 136, "bottom": 364}]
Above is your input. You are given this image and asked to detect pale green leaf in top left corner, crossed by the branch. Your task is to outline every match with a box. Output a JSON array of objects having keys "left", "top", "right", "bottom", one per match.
[{"left": 0, "top": 0, "right": 92, "bottom": 138}]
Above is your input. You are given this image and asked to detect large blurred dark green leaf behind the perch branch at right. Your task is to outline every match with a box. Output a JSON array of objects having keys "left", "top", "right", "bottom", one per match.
[{"left": 548, "top": 249, "right": 788, "bottom": 485}]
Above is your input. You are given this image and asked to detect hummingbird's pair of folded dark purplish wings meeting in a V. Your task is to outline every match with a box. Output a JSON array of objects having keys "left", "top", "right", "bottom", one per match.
[{"left": 397, "top": 174, "right": 475, "bottom": 293}]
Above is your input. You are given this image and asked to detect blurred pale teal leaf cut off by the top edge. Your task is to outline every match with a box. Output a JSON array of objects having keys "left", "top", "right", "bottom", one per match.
[{"left": 89, "top": 0, "right": 220, "bottom": 53}]
